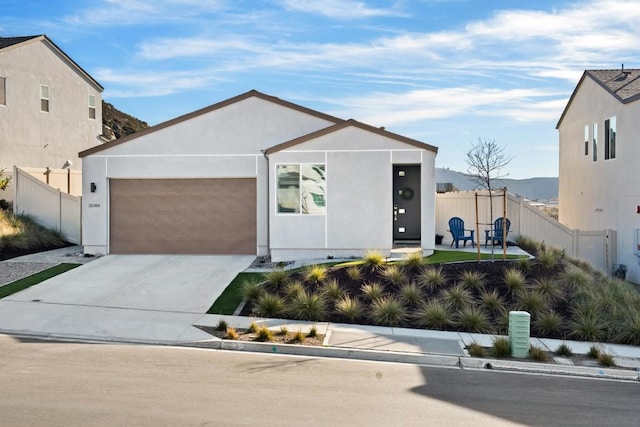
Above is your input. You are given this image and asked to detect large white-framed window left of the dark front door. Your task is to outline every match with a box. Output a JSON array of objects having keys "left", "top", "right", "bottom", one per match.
[{"left": 276, "top": 163, "right": 327, "bottom": 215}]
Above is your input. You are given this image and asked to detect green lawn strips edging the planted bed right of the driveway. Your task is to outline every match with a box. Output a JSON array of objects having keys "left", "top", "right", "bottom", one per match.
[{"left": 207, "top": 251, "right": 526, "bottom": 315}]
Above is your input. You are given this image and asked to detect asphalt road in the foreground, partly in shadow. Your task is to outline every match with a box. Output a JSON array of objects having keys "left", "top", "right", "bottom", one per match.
[{"left": 0, "top": 336, "right": 640, "bottom": 426}]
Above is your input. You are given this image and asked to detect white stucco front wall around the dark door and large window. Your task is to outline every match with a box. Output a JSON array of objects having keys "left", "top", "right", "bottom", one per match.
[{"left": 269, "top": 127, "right": 435, "bottom": 261}]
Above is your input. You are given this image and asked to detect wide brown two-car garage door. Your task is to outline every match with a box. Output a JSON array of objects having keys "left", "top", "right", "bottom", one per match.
[{"left": 109, "top": 178, "right": 256, "bottom": 254}]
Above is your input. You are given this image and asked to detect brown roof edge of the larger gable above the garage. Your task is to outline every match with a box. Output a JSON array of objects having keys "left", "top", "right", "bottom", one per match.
[{"left": 79, "top": 90, "right": 344, "bottom": 157}]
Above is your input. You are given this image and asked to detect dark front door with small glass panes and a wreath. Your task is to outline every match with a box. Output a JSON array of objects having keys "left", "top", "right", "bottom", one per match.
[{"left": 393, "top": 165, "right": 421, "bottom": 243}]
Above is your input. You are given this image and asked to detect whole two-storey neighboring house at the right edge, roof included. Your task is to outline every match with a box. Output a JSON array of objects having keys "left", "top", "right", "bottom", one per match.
[{"left": 557, "top": 69, "right": 640, "bottom": 283}]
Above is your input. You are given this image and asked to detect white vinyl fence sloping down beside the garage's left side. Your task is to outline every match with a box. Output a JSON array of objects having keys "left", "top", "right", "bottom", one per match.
[{"left": 13, "top": 167, "right": 82, "bottom": 244}]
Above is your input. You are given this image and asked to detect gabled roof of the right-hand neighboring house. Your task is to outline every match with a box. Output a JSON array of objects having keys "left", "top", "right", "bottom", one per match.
[{"left": 556, "top": 68, "right": 640, "bottom": 129}]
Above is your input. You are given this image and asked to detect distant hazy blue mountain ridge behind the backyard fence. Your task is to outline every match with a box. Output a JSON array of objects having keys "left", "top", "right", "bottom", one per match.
[{"left": 436, "top": 168, "right": 558, "bottom": 201}]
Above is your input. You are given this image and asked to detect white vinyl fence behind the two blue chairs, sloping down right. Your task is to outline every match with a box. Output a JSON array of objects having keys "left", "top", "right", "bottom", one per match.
[{"left": 436, "top": 190, "right": 616, "bottom": 274}]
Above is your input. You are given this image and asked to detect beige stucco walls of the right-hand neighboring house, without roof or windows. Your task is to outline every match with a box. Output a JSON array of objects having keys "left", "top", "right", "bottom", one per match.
[{"left": 559, "top": 77, "right": 640, "bottom": 283}]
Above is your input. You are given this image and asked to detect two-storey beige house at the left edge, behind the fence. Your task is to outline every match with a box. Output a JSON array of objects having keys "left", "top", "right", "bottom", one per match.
[{"left": 0, "top": 35, "right": 103, "bottom": 197}]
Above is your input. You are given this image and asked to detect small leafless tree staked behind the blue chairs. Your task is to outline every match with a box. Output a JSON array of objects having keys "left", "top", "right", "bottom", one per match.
[{"left": 467, "top": 138, "right": 513, "bottom": 244}]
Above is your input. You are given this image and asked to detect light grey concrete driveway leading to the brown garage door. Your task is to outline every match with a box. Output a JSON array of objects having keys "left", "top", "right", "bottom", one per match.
[{"left": 0, "top": 255, "right": 255, "bottom": 342}]
